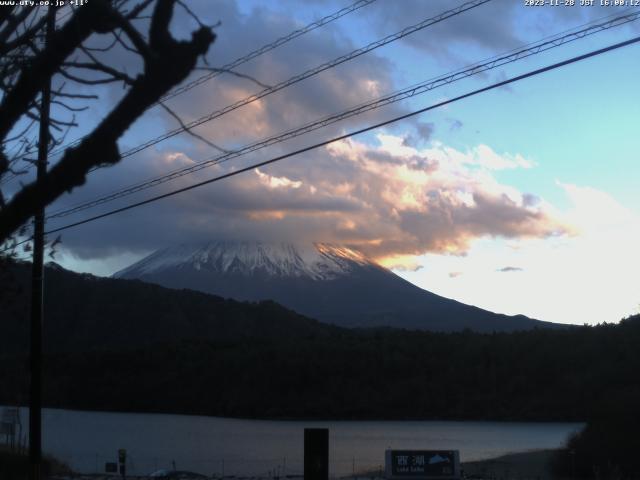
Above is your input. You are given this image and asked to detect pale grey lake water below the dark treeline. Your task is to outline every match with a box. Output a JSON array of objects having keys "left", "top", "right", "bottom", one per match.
[{"left": 6, "top": 408, "right": 582, "bottom": 476}]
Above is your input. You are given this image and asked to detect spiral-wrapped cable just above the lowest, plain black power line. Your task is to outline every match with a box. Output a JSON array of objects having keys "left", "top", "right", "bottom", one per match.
[{"left": 47, "top": 12, "right": 640, "bottom": 219}]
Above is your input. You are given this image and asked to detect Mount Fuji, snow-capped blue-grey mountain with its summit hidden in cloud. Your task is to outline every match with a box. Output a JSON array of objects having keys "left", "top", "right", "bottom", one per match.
[{"left": 114, "top": 241, "right": 559, "bottom": 332}]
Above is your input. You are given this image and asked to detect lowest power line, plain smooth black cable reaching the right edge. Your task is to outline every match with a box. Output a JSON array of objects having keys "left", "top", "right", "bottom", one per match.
[{"left": 32, "top": 36, "right": 640, "bottom": 244}]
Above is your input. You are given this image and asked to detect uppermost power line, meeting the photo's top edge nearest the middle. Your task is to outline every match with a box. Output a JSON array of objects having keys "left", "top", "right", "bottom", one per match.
[{"left": 1, "top": 0, "right": 377, "bottom": 180}]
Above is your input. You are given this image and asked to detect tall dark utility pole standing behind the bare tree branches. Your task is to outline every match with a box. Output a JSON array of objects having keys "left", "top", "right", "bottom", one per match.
[{"left": 29, "top": 6, "right": 56, "bottom": 480}]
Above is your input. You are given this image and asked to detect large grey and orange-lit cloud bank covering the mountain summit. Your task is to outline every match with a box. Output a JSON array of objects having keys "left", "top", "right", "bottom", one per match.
[{"left": 50, "top": 133, "right": 570, "bottom": 269}]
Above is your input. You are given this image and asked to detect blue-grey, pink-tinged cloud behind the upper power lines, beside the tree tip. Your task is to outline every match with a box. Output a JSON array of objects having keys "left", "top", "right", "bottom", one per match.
[{"left": 145, "top": 1, "right": 406, "bottom": 157}]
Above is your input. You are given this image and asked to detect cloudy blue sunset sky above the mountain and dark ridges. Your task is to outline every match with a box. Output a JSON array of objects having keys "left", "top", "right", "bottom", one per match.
[{"left": 9, "top": 0, "right": 640, "bottom": 324}]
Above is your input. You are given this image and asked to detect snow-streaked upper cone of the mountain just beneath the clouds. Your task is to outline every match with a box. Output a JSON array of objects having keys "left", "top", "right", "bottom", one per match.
[{"left": 114, "top": 241, "right": 377, "bottom": 280}]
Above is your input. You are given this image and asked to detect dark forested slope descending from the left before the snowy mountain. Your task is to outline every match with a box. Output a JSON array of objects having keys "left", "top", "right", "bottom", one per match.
[{"left": 0, "top": 263, "right": 338, "bottom": 353}]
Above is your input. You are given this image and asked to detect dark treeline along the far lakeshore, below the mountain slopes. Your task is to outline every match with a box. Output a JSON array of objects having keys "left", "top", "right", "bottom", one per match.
[{"left": 0, "top": 317, "right": 640, "bottom": 421}]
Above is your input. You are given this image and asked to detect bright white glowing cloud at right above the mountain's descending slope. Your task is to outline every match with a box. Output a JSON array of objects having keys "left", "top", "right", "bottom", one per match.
[{"left": 401, "top": 182, "right": 640, "bottom": 325}]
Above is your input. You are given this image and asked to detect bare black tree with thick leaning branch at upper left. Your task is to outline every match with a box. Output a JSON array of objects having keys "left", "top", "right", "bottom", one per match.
[{"left": 0, "top": 0, "right": 215, "bottom": 244}]
